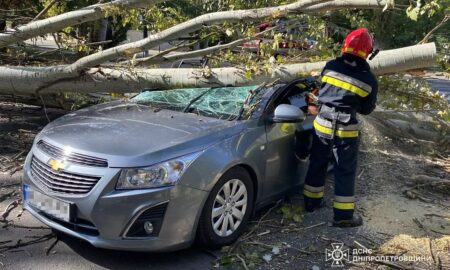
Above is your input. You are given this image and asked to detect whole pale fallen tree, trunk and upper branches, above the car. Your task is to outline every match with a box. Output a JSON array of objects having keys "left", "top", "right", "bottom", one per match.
[{"left": 0, "top": 0, "right": 436, "bottom": 95}]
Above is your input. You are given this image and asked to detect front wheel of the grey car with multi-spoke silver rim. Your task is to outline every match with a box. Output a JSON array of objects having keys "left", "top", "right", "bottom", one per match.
[{"left": 197, "top": 167, "right": 254, "bottom": 249}]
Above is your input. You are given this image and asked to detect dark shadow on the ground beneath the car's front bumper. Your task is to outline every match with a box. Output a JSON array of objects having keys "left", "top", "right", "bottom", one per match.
[{"left": 58, "top": 234, "right": 218, "bottom": 270}]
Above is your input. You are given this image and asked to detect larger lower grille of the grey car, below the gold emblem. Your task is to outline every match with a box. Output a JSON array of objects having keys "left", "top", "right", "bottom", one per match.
[{"left": 31, "top": 156, "right": 101, "bottom": 194}]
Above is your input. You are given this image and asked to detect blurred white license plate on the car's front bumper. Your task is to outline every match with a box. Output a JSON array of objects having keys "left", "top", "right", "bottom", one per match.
[{"left": 23, "top": 185, "right": 73, "bottom": 222}]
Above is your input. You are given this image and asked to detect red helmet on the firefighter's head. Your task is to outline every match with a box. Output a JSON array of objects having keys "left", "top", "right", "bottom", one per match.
[{"left": 342, "top": 28, "right": 373, "bottom": 59}]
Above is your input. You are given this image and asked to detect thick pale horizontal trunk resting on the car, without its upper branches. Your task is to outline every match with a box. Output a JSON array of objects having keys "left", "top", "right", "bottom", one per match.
[{"left": 0, "top": 43, "right": 436, "bottom": 94}]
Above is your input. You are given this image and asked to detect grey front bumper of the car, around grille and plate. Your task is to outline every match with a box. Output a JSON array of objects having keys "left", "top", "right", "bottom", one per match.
[{"left": 23, "top": 147, "right": 208, "bottom": 251}]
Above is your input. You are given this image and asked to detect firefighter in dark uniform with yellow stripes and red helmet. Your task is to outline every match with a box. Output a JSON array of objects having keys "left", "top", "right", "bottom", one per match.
[{"left": 303, "top": 28, "right": 378, "bottom": 227}]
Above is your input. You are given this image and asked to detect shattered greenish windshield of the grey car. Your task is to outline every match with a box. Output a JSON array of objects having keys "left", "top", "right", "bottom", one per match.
[{"left": 131, "top": 85, "right": 266, "bottom": 120}]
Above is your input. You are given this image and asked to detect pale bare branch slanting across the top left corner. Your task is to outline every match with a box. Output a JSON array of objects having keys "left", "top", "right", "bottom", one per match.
[{"left": 0, "top": 0, "right": 165, "bottom": 48}]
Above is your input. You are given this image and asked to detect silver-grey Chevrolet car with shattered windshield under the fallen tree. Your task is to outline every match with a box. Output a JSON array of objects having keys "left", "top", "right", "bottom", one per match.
[{"left": 23, "top": 80, "right": 312, "bottom": 251}]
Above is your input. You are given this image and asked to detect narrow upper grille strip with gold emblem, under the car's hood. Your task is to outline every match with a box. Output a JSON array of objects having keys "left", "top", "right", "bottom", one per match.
[{"left": 37, "top": 140, "right": 108, "bottom": 167}]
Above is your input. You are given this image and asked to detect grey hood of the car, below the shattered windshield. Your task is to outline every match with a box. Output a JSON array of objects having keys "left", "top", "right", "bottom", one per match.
[{"left": 36, "top": 102, "right": 244, "bottom": 167}]
